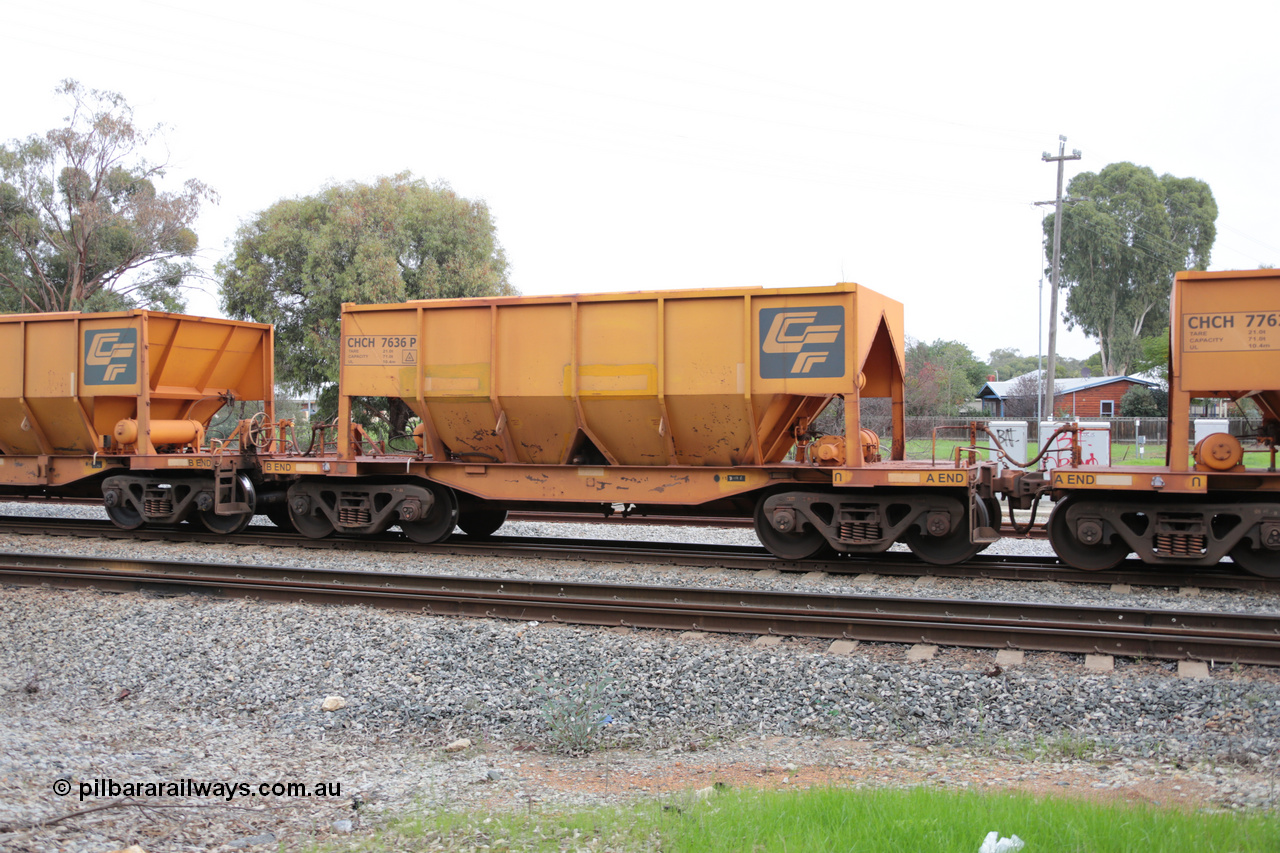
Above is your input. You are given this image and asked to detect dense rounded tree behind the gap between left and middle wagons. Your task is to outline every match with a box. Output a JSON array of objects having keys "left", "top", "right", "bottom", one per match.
[{"left": 218, "top": 173, "right": 515, "bottom": 398}]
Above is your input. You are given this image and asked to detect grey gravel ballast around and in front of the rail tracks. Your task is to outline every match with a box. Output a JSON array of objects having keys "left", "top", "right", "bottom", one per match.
[{"left": 0, "top": 507, "right": 1280, "bottom": 850}]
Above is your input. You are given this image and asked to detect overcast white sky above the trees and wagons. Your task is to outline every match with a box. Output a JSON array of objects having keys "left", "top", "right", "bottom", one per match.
[{"left": 0, "top": 0, "right": 1280, "bottom": 357}]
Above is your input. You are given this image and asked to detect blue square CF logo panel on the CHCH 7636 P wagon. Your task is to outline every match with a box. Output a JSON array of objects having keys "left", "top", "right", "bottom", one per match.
[{"left": 760, "top": 305, "right": 845, "bottom": 379}]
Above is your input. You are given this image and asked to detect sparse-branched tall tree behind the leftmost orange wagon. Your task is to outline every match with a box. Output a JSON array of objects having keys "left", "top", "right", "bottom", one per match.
[{"left": 0, "top": 79, "right": 215, "bottom": 311}]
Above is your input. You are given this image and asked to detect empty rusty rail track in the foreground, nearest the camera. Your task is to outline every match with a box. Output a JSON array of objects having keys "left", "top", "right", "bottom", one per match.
[{"left": 0, "top": 553, "right": 1280, "bottom": 666}]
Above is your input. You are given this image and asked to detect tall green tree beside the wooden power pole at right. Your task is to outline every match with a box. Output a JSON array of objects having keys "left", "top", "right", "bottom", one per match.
[{"left": 1044, "top": 163, "right": 1217, "bottom": 375}]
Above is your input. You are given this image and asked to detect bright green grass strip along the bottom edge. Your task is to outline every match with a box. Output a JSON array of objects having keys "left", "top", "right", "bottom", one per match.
[{"left": 358, "top": 788, "right": 1280, "bottom": 853}]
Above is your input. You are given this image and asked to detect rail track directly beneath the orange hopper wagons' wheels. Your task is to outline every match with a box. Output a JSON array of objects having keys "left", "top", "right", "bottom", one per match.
[{"left": 0, "top": 516, "right": 1280, "bottom": 592}]
